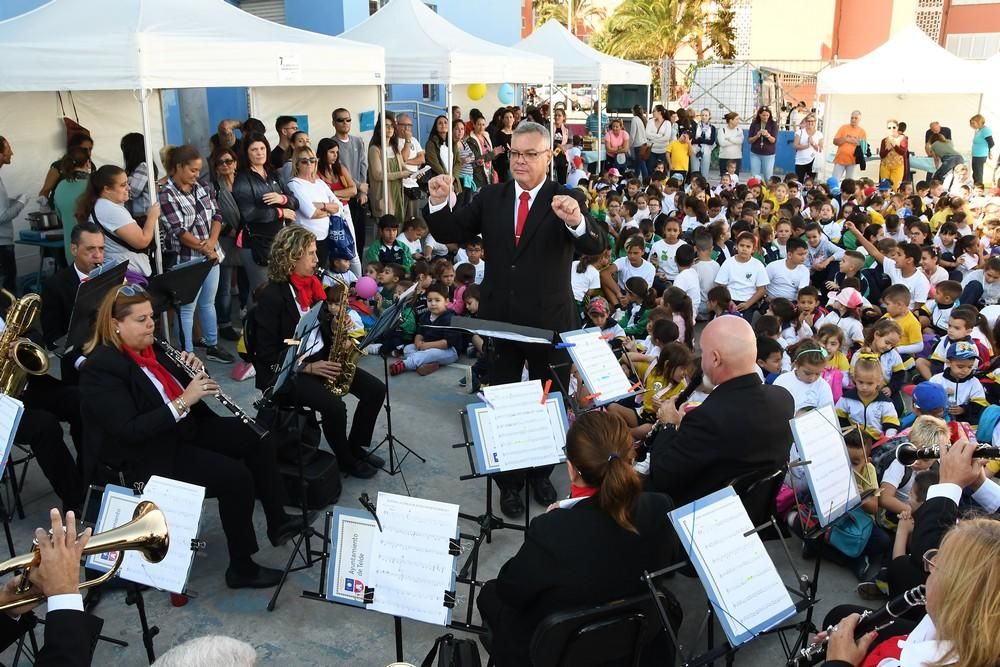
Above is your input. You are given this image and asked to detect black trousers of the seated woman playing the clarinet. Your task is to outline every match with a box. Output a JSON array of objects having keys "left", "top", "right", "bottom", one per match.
[{"left": 125, "top": 416, "right": 284, "bottom": 561}]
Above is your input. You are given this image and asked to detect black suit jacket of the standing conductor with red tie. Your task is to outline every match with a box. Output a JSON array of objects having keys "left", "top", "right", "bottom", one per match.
[{"left": 424, "top": 181, "right": 607, "bottom": 332}]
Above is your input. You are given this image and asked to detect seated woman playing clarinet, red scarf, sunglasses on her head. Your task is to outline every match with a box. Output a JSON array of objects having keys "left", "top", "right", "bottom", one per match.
[{"left": 80, "top": 285, "right": 301, "bottom": 588}]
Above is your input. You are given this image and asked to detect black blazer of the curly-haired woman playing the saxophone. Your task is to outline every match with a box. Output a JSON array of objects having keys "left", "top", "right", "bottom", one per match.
[{"left": 253, "top": 282, "right": 330, "bottom": 390}]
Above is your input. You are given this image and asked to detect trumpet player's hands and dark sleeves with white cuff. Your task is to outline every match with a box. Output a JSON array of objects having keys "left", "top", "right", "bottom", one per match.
[{"left": 0, "top": 509, "right": 104, "bottom": 667}]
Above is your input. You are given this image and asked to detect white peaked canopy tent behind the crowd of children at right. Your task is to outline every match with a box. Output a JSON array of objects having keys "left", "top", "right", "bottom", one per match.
[{"left": 816, "top": 25, "right": 989, "bottom": 179}]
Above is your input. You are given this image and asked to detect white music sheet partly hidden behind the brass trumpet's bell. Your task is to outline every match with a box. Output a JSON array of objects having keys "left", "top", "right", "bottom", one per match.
[{"left": 119, "top": 475, "right": 204, "bottom": 593}]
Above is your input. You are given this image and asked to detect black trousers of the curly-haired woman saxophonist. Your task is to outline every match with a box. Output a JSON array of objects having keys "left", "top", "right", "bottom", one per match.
[{"left": 295, "top": 368, "right": 385, "bottom": 469}]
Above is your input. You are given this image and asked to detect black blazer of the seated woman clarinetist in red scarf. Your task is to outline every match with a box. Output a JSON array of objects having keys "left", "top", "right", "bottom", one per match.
[{"left": 80, "top": 345, "right": 220, "bottom": 482}]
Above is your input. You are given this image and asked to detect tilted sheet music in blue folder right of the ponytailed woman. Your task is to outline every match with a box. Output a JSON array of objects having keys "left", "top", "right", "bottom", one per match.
[{"left": 669, "top": 486, "right": 795, "bottom": 647}]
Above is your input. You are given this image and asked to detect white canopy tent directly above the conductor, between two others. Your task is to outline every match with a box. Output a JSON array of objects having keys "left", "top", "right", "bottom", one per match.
[{"left": 343, "top": 0, "right": 552, "bottom": 180}]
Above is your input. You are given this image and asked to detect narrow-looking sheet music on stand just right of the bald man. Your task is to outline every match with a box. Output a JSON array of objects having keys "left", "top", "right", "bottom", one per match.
[{"left": 788, "top": 405, "right": 861, "bottom": 527}]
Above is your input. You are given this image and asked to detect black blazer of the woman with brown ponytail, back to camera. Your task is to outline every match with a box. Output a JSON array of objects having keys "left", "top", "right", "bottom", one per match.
[{"left": 497, "top": 493, "right": 678, "bottom": 647}]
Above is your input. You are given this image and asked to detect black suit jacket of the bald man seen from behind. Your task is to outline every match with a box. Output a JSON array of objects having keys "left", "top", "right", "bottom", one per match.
[{"left": 649, "top": 373, "right": 795, "bottom": 506}]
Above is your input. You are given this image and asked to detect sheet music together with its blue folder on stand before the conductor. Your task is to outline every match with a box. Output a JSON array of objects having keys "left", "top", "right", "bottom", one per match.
[{"left": 466, "top": 380, "right": 569, "bottom": 475}]
